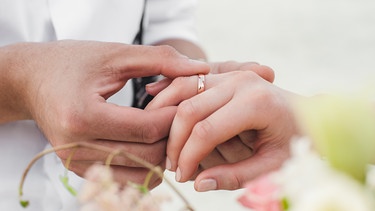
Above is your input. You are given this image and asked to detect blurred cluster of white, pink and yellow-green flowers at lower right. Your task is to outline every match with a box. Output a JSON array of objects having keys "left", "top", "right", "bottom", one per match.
[{"left": 239, "top": 96, "right": 375, "bottom": 211}]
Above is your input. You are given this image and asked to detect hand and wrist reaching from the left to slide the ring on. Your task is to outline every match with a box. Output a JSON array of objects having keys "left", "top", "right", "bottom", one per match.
[{"left": 0, "top": 40, "right": 210, "bottom": 187}]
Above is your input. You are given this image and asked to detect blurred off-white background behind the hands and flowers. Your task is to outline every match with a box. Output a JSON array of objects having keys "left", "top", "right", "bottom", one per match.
[{"left": 155, "top": 0, "right": 375, "bottom": 211}]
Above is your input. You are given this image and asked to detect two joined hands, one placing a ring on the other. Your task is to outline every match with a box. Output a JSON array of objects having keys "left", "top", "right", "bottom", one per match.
[{"left": 0, "top": 41, "right": 296, "bottom": 191}]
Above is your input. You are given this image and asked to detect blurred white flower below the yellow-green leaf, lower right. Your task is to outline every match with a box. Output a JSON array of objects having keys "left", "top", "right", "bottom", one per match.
[{"left": 273, "top": 138, "right": 375, "bottom": 211}]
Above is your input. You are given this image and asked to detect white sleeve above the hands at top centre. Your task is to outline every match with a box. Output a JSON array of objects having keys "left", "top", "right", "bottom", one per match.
[{"left": 143, "top": 0, "right": 197, "bottom": 44}]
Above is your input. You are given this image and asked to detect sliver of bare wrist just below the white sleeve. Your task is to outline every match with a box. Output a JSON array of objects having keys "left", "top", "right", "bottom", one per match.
[{"left": 154, "top": 39, "right": 207, "bottom": 60}]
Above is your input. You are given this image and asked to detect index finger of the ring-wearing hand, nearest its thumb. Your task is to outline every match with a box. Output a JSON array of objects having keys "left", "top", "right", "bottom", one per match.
[{"left": 176, "top": 99, "right": 253, "bottom": 182}]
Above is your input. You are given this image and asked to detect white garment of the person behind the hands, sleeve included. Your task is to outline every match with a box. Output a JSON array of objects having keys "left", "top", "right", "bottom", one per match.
[{"left": 0, "top": 0, "right": 200, "bottom": 211}]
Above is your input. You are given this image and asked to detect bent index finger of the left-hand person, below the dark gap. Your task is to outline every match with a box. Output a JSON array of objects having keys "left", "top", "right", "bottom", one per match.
[{"left": 87, "top": 103, "right": 176, "bottom": 143}]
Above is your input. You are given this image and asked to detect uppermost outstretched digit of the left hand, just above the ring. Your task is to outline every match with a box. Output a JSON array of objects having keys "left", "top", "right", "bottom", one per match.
[{"left": 110, "top": 45, "right": 210, "bottom": 80}]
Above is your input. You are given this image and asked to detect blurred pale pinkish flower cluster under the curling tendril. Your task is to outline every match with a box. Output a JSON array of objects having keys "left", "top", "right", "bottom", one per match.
[{"left": 78, "top": 165, "right": 171, "bottom": 211}]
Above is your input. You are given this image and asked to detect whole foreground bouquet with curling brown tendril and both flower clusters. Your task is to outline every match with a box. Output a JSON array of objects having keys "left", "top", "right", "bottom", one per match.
[{"left": 19, "top": 92, "right": 375, "bottom": 211}]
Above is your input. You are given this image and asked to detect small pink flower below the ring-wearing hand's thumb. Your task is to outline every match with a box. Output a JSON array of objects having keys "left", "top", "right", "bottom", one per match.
[{"left": 238, "top": 174, "right": 283, "bottom": 211}]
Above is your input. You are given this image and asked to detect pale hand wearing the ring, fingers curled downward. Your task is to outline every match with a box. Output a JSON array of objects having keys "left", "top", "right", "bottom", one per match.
[{"left": 147, "top": 69, "right": 300, "bottom": 191}]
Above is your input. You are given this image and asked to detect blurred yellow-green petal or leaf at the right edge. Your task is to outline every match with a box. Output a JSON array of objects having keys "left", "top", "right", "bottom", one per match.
[{"left": 297, "top": 96, "right": 375, "bottom": 183}]
